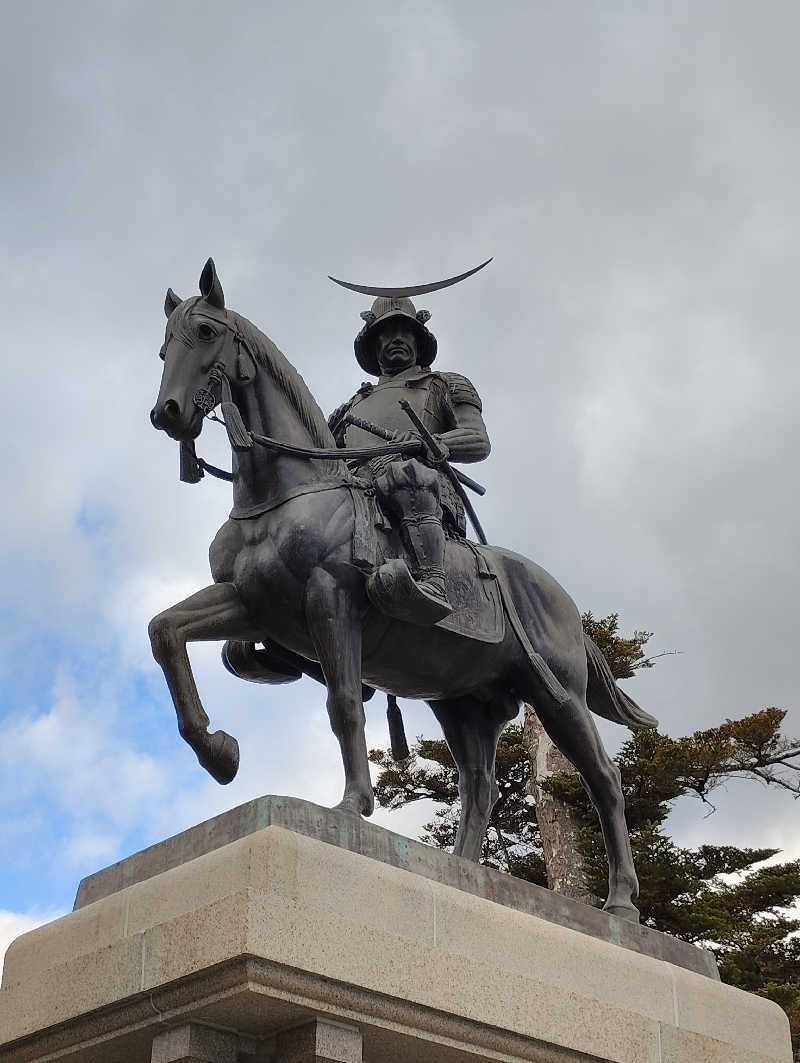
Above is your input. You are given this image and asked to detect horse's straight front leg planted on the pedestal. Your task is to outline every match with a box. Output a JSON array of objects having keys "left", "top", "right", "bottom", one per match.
[{"left": 306, "top": 569, "right": 375, "bottom": 815}]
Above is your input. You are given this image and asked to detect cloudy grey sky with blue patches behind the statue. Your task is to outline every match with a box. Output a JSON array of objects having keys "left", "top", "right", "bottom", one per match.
[{"left": 0, "top": 0, "right": 800, "bottom": 965}]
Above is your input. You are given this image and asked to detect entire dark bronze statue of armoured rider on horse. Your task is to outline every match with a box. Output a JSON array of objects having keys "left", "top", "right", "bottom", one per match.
[{"left": 150, "top": 259, "right": 656, "bottom": 919}]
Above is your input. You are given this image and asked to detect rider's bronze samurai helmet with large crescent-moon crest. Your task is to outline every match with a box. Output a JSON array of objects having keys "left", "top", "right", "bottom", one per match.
[{"left": 329, "top": 258, "right": 492, "bottom": 376}]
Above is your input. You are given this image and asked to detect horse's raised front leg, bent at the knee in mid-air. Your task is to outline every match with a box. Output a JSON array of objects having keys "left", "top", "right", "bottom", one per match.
[{"left": 149, "top": 584, "right": 259, "bottom": 783}]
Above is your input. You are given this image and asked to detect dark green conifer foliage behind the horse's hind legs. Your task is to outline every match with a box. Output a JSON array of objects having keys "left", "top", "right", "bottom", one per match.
[{"left": 370, "top": 613, "right": 800, "bottom": 1061}]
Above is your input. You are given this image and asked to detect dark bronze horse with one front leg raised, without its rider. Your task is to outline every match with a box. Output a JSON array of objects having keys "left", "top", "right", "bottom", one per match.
[{"left": 150, "top": 259, "right": 656, "bottom": 919}]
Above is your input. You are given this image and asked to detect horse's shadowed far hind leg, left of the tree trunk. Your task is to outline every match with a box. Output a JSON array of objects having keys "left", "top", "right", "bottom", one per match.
[{"left": 428, "top": 697, "right": 520, "bottom": 861}]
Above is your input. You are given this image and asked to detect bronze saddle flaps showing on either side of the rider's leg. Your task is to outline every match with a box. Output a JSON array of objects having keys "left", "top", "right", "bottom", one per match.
[{"left": 352, "top": 488, "right": 506, "bottom": 643}]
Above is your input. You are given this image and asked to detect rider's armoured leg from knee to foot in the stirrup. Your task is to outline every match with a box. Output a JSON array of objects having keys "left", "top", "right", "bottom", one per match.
[{"left": 367, "top": 459, "right": 453, "bottom": 627}]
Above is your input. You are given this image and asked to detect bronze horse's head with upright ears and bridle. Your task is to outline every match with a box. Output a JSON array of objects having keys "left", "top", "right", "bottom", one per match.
[{"left": 150, "top": 258, "right": 255, "bottom": 440}]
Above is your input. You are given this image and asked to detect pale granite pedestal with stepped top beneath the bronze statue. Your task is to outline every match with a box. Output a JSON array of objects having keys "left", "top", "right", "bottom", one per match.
[{"left": 0, "top": 798, "right": 792, "bottom": 1063}]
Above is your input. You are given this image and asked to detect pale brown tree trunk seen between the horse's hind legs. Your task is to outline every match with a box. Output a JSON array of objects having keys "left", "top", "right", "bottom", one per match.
[{"left": 524, "top": 705, "right": 598, "bottom": 905}]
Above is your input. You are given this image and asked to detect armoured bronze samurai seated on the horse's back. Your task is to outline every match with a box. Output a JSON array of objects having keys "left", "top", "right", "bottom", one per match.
[{"left": 328, "top": 293, "right": 491, "bottom": 625}]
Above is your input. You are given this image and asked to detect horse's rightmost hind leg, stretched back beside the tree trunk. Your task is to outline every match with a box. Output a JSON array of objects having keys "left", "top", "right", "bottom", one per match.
[{"left": 529, "top": 691, "right": 639, "bottom": 922}]
